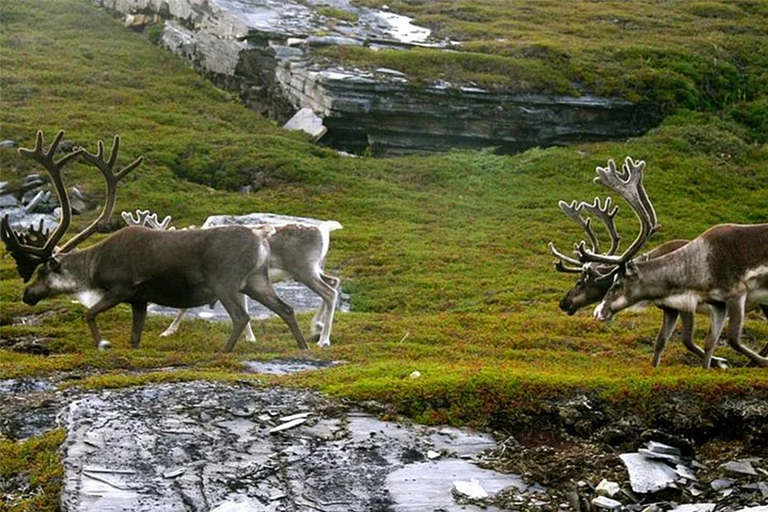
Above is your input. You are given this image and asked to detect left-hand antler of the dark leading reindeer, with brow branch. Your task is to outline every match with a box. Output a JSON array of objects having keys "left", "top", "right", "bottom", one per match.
[{"left": 0, "top": 130, "right": 83, "bottom": 282}]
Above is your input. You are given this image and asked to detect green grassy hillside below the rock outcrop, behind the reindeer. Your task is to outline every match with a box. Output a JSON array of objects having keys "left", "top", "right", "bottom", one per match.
[{"left": 0, "top": 0, "right": 768, "bottom": 508}]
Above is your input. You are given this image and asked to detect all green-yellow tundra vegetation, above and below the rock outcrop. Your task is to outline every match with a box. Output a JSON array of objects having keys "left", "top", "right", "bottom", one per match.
[{"left": 0, "top": 0, "right": 768, "bottom": 510}]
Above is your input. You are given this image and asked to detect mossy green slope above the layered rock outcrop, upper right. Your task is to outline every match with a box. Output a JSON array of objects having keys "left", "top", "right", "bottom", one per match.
[{"left": 338, "top": 0, "right": 768, "bottom": 111}]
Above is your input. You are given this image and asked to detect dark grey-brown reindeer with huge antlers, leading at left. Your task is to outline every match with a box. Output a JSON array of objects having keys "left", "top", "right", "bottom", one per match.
[{"left": 0, "top": 132, "right": 307, "bottom": 352}]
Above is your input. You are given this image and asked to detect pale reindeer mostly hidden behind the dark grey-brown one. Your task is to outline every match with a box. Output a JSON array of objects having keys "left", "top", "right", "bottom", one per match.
[{"left": 122, "top": 210, "right": 342, "bottom": 347}]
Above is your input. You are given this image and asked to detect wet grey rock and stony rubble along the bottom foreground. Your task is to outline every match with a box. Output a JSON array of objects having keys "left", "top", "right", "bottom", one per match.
[{"left": 0, "top": 370, "right": 768, "bottom": 512}]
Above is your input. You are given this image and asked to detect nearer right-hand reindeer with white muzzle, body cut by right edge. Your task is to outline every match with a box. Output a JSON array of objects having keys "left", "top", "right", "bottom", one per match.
[{"left": 550, "top": 158, "right": 768, "bottom": 368}]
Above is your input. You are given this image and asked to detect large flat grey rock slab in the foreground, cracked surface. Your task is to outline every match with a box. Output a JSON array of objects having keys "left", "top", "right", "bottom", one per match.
[{"left": 62, "top": 382, "right": 525, "bottom": 512}]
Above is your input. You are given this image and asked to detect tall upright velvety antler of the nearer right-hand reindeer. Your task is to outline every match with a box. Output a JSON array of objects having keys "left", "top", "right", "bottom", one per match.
[{"left": 575, "top": 157, "right": 661, "bottom": 266}]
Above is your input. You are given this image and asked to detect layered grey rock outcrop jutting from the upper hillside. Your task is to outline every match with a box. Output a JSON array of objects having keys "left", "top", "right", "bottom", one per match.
[{"left": 97, "top": 0, "right": 659, "bottom": 154}]
